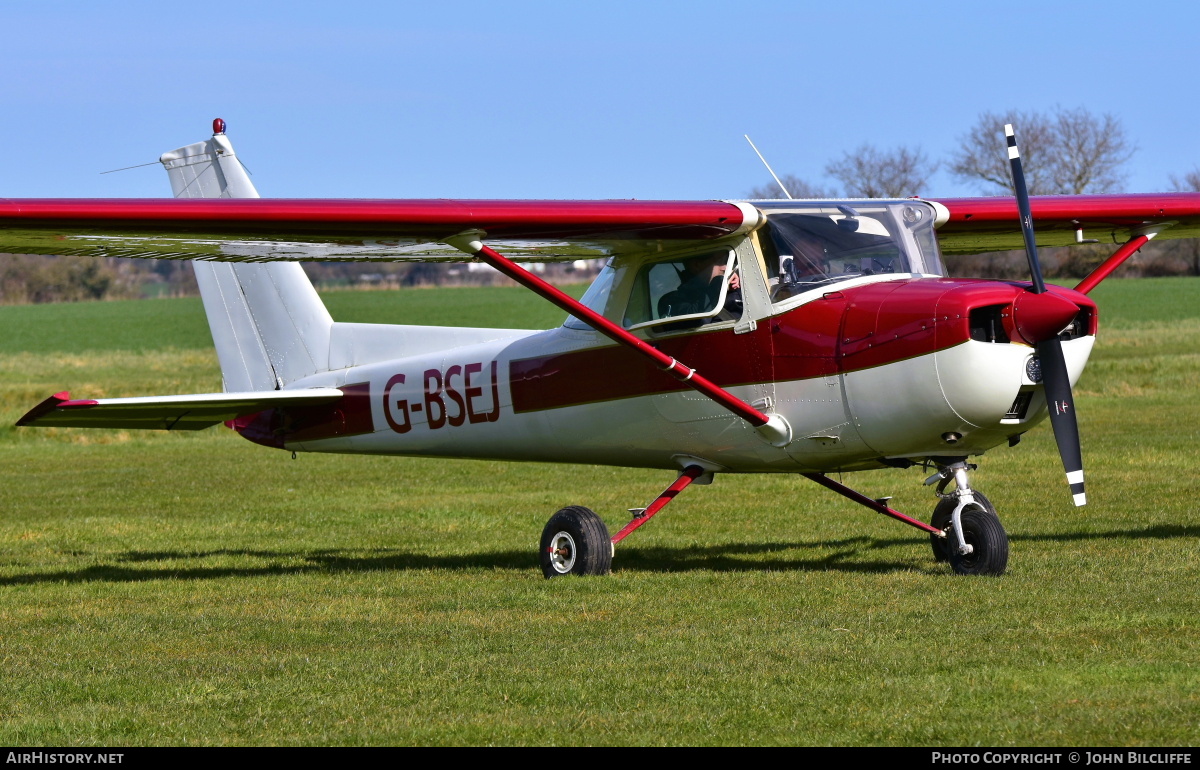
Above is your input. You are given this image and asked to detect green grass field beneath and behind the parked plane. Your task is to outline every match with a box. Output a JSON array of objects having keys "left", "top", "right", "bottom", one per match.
[{"left": 0, "top": 278, "right": 1200, "bottom": 746}]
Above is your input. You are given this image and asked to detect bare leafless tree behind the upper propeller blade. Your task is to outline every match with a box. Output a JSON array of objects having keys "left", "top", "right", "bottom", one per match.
[{"left": 950, "top": 107, "right": 1134, "bottom": 195}]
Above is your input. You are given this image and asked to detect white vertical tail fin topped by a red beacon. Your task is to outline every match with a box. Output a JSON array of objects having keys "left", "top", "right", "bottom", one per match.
[{"left": 158, "top": 119, "right": 334, "bottom": 392}]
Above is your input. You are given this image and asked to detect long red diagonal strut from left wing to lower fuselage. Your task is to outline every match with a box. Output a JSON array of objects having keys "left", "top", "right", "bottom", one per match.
[{"left": 443, "top": 230, "right": 792, "bottom": 446}]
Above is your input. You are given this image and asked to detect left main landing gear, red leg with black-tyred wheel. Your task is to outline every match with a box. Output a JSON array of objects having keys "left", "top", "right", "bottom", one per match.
[{"left": 541, "top": 465, "right": 704, "bottom": 578}]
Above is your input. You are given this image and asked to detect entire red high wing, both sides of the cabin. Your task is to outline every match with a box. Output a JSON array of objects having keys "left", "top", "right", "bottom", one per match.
[{"left": 0, "top": 192, "right": 1200, "bottom": 261}]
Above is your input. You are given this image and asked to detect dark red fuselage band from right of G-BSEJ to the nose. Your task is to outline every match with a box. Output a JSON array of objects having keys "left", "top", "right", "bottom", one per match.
[{"left": 509, "top": 278, "right": 1094, "bottom": 413}]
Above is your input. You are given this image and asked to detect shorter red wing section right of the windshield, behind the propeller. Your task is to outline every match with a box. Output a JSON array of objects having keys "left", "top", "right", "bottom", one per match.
[{"left": 931, "top": 192, "right": 1200, "bottom": 254}]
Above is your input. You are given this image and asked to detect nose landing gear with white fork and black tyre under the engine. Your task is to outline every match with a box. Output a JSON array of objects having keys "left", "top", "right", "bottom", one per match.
[{"left": 925, "top": 458, "right": 1008, "bottom": 575}]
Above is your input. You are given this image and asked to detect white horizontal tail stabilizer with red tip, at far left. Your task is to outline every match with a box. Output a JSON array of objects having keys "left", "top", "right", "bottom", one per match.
[{"left": 17, "top": 387, "right": 344, "bottom": 431}]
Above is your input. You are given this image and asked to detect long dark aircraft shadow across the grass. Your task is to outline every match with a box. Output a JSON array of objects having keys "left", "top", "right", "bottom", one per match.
[{"left": 0, "top": 524, "right": 1200, "bottom": 585}]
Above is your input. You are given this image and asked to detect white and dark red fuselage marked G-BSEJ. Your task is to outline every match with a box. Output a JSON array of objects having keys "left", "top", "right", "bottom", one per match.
[{"left": 235, "top": 273, "right": 1097, "bottom": 473}]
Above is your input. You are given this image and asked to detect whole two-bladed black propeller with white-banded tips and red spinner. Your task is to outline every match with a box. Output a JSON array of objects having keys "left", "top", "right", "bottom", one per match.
[{"left": 1004, "top": 124, "right": 1087, "bottom": 505}]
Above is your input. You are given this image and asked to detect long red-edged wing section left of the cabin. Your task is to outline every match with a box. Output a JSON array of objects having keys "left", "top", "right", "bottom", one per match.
[{"left": 0, "top": 198, "right": 761, "bottom": 261}]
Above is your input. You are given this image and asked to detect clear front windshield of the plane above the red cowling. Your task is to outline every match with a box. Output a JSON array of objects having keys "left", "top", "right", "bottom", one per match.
[{"left": 758, "top": 201, "right": 942, "bottom": 302}]
